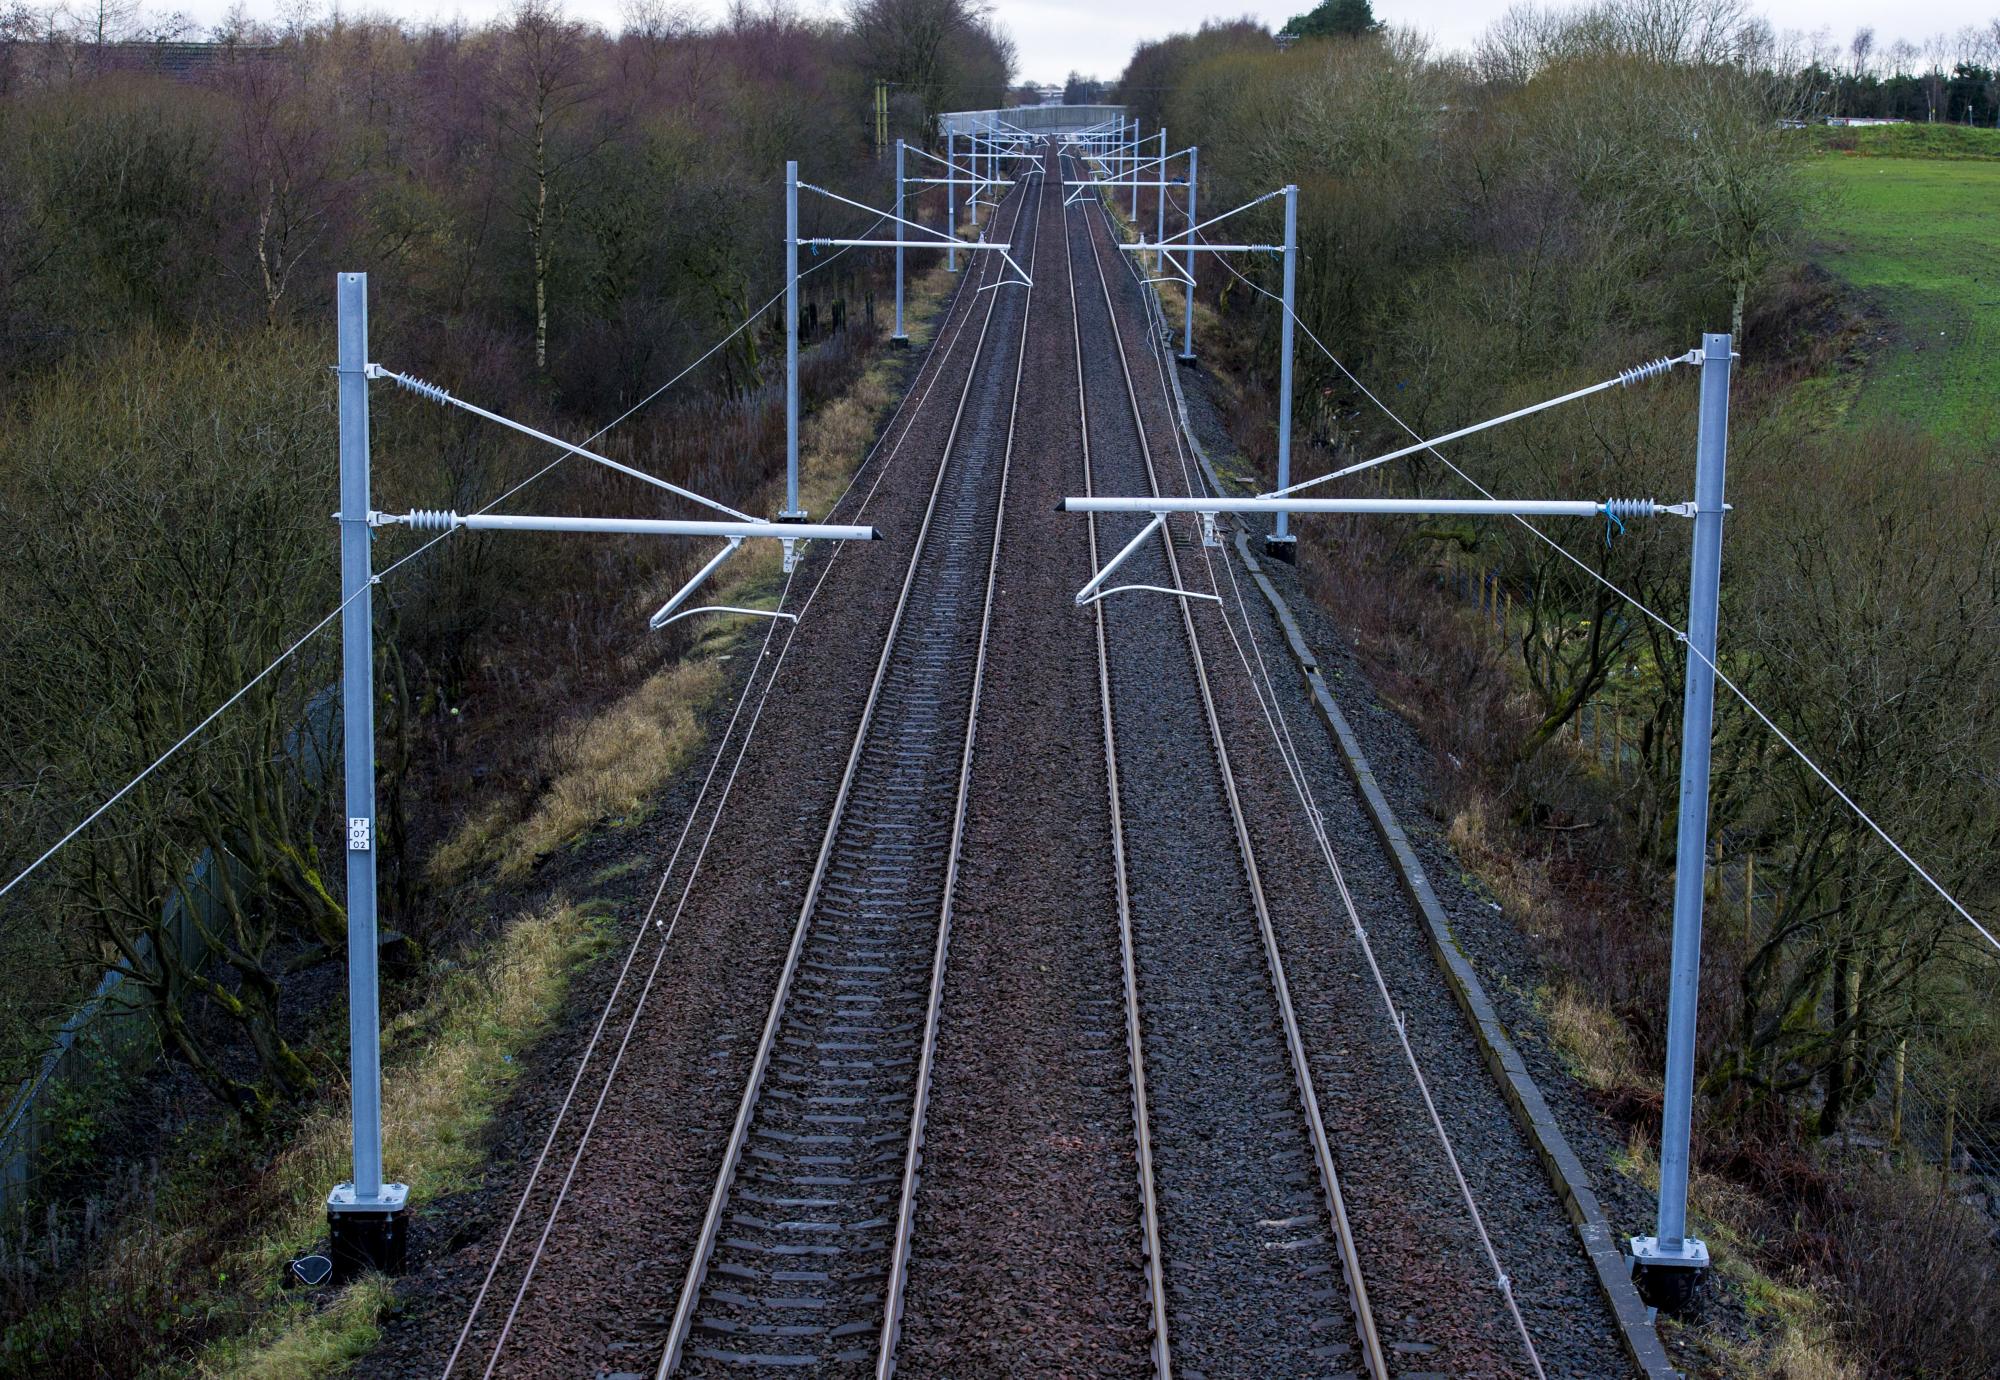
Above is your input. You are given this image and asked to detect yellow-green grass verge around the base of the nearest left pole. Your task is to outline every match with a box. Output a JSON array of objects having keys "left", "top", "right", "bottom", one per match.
[{"left": 0, "top": 900, "right": 610, "bottom": 1378}]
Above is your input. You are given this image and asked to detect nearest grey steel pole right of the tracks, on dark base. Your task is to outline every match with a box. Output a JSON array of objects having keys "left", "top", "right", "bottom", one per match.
[{"left": 1632, "top": 334, "right": 1732, "bottom": 1304}]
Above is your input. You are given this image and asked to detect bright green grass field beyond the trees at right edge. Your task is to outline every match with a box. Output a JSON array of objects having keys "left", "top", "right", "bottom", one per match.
[{"left": 1808, "top": 126, "right": 2000, "bottom": 444}]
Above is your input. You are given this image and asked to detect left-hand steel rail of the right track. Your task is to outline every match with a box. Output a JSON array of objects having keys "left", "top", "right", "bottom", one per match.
[{"left": 1060, "top": 154, "right": 1174, "bottom": 1380}]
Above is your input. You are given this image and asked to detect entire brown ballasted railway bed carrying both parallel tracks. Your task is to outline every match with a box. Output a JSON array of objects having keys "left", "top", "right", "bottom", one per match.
[{"left": 382, "top": 134, "right": 1616, "bottom": 1380}]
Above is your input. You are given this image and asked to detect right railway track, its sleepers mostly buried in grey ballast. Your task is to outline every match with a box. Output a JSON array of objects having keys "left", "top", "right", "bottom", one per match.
[{"left": 1064, "top": 150, "right": 1388, "bottom": 1380}]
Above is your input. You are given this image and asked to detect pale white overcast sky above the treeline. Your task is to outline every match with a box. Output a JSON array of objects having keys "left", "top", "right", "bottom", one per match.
[{"left": 176, "top": 0, "right": 2000, "bottom": 82}]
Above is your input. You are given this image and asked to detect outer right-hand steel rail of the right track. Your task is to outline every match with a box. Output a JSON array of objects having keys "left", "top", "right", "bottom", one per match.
[{"left": 1084, "top": 156, "right": 1388, "bottom": 1380}]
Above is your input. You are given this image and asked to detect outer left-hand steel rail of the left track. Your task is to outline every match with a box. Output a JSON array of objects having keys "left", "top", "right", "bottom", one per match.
[{"left": 654, "top": 153, "right": 1020, "bottom": 1380}]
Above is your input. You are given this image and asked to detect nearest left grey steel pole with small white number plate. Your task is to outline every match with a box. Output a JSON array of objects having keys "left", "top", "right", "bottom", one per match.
[{"left": 326, "top": 274, "right": 408, "bottom": 1280}]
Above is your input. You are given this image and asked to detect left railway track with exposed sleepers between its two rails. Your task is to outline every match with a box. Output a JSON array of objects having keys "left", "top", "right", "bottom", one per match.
[{"left": 658, "top": 145, "right": 1042, "bottom": 1380}]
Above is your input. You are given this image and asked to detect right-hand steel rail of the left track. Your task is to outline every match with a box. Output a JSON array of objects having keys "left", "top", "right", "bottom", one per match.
[{"left": 876, "top": 150, "right": 1046, "bottom": 1380}]
